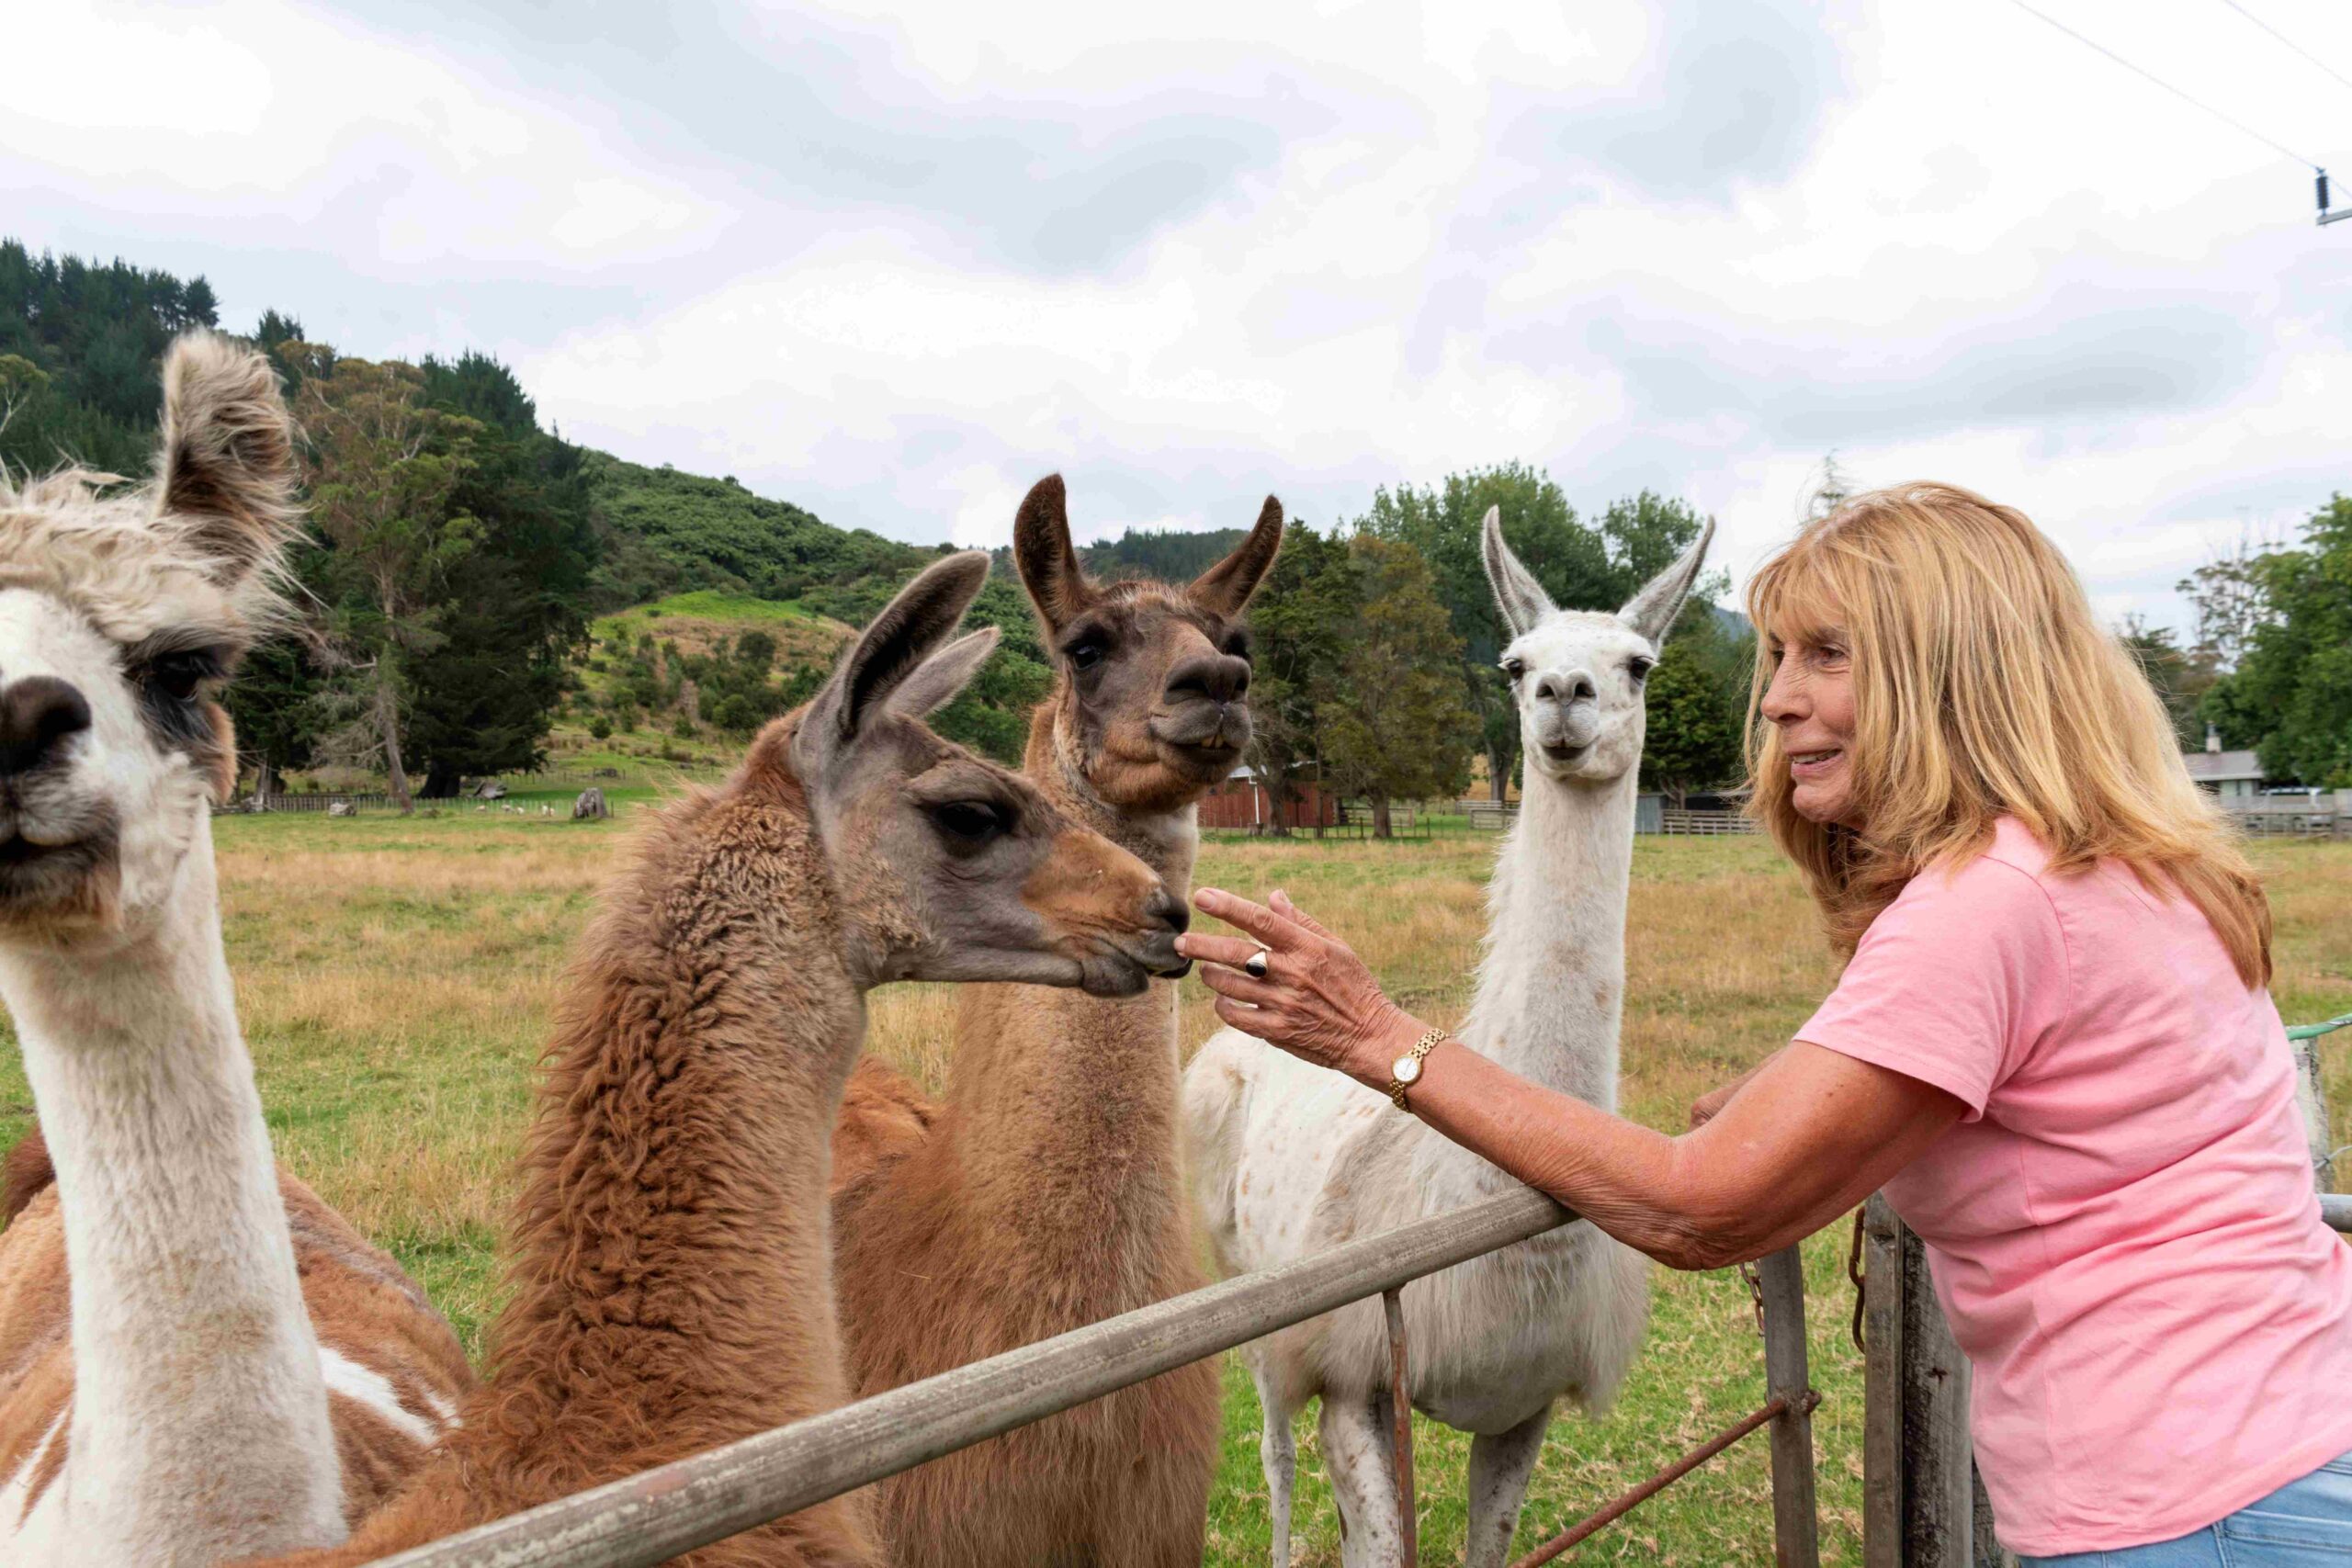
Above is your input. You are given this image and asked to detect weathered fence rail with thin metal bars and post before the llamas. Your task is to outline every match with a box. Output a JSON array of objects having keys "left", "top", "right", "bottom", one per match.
[{"left": 353, "top": 1190, "right": 1820, "bottom": 1568}]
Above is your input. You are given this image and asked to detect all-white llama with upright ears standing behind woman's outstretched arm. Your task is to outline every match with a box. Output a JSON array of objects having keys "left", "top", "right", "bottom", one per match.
[{"left": 1183, "top": 510, "right": 1714, "bottom": 1568}]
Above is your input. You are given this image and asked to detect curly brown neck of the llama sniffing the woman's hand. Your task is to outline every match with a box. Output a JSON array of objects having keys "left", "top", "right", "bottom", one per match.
[{"left": 480, "top": 802, "right": 865, "bottom": 1483}]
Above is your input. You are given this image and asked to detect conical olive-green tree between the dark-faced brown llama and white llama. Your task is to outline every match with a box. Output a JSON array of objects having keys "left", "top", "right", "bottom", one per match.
[{"left": 1315, "top": 534, "right": 1477, "bottom": 840}]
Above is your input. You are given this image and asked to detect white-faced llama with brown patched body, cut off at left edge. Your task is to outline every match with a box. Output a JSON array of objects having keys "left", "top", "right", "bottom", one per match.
[{"left": 0, "top": 333, "right": 470, "bottom": 1568}]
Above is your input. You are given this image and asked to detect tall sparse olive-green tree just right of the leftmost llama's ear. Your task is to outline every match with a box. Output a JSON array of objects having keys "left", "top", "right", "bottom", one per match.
[{"left": 299, "top": 344, "right": 480, "bottom": 813}]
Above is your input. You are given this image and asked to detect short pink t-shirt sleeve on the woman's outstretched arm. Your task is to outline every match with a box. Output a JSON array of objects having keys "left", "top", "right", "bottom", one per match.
[{"left": 1797, "top": 856, "right": 2070, "bottom": 1122}]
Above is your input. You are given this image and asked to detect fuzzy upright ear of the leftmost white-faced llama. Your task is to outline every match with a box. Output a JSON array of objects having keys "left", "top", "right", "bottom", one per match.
[{"left": 158, "top": 332, "right": 301, "bottom": 583}]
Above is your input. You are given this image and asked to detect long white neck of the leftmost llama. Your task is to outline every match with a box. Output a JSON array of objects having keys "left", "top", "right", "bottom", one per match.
[{"left": 0, "top": 825, "right": 344, "bottom": 1563}]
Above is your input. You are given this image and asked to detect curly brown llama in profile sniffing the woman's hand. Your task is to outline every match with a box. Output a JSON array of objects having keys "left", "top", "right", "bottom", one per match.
[{"left": 257, "top": 552, "right": 1183, "bottom": 1568}]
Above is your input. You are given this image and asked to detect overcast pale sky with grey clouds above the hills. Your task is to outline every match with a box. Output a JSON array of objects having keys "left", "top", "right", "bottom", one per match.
[{"left": 0, "top": 0, "right": 2352, "bottom": 621}]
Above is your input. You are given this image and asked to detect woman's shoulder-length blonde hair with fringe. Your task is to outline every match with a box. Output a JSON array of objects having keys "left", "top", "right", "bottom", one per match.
[{"left": 1747, "top": 484, "right": 2269, "bottom": 989}]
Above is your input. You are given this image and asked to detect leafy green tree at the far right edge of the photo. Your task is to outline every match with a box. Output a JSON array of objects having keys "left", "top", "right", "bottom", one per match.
[{"left": 2204, "top": 496, "right": 2352, "bottom": 787}]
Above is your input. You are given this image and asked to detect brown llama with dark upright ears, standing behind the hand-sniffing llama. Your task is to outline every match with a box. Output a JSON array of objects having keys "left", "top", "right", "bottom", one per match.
[{"left": 832, "top": 478, "right": 1282, "bottom": 1568}]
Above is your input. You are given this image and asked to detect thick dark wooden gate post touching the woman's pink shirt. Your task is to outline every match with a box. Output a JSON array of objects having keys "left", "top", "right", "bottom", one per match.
[{"left": 1863, "top": 1194, "right": 2016, "bottom": 1568}]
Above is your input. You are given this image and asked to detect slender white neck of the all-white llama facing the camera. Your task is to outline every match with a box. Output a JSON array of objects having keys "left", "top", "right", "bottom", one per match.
[{"left": 1463, "top": 773, "right": 1634, "bottom": 1110}]
